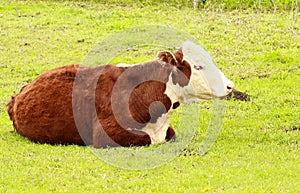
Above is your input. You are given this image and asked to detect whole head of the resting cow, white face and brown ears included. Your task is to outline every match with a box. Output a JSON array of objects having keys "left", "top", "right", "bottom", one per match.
[{"left": 158, "top": 42, "right": 234, "bottom": 102}]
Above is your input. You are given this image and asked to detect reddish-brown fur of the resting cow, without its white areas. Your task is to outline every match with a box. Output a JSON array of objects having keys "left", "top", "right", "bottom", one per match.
[{"left": 7, "top": 49, "right": 190, "bottom": 147}]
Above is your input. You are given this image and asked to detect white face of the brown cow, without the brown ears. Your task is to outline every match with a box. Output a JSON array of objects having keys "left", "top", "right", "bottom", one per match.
[{"left": 182, "top": 42, "right": 234, "bottom": 102}]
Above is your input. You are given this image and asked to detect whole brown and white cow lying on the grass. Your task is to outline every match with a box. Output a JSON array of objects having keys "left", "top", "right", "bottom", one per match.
[{"left": 7, "top": 42, "right": 233, "bottom": 148}]
